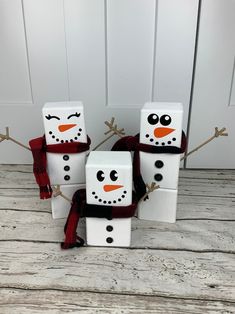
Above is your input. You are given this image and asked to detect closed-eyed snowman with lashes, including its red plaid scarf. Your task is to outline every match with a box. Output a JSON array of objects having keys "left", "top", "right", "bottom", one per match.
[{"left": 29, "top": 101, "right": 90, "bottom": 218}]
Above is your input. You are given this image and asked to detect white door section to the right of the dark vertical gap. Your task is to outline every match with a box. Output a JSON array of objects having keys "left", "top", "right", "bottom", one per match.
[{"left": 187, "top": 0, "right": 235, "bottom": 168}]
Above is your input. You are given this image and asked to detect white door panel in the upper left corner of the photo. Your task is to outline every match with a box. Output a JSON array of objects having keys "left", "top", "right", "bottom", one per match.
[{"left": 0, "top": 0, "right": 32, "bottom": 103}]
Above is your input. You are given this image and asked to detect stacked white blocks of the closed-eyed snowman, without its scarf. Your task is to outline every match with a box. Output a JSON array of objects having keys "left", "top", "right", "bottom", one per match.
[{"left": 42, "top": 101, "right": 88, "bottom": 218}]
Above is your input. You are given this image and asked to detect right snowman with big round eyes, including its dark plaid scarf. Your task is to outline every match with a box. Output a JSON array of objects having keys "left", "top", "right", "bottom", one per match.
[{"left": 112, "top": 102, "right": 186, "bottom": 222}]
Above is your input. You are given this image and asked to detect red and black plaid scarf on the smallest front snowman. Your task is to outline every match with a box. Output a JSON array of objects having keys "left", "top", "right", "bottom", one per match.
[{"left": 61, "top": 189, "right": 138, "bottom": 249}]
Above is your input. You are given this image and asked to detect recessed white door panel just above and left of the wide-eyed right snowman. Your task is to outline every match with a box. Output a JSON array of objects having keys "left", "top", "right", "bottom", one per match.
[{"left": 106, "top": 0, "right": 157, "bottom": 107}]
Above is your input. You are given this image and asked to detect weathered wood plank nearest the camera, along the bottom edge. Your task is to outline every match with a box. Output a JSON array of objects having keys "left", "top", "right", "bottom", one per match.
[{"left": 0, "top": 289, "right": 235, "bottom": 314}]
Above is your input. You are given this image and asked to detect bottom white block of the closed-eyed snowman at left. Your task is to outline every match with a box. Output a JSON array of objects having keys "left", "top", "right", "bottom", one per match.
[{"left": 51, "top": 184, "right": 85, "bottom": 219}]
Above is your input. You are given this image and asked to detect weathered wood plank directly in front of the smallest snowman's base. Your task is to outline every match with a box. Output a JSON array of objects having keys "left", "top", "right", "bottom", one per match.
[{"left": 0, "top": 242, "right": 235, "bottom": 302}]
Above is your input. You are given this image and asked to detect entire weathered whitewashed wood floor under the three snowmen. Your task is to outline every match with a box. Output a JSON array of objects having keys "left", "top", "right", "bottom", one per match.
[{"left": 0, "top": 165, "right": 235, "bottom": 314}]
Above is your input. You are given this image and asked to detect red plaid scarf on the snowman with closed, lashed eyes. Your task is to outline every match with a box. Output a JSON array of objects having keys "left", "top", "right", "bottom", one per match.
[{"left": 29, "top": 135, "right": 91, "bottom": 199}]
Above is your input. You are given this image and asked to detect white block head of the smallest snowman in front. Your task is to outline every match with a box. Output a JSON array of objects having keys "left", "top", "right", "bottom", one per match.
[{"left": 86, "top": 151, "right": 132, "bottom": 206}]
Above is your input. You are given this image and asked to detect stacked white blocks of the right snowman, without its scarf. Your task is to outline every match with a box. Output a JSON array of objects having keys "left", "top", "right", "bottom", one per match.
[{"left": 138, "top": 102, "right": 183, "bottom": 222}]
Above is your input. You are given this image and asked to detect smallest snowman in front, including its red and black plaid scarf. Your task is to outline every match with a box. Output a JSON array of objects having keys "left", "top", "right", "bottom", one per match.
[{"left": 62, "top": 151, "right": 137, "bottom": 249}]
